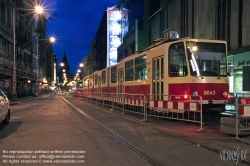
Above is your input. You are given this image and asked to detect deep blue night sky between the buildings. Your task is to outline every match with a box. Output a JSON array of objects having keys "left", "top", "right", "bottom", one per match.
[{"left": 42, "top": 0, "right": 119, "bottom": 74}]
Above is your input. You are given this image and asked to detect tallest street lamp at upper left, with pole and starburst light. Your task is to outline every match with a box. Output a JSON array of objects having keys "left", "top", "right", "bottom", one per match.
[{"left": 12, "top": 5, "right": 43, "bottom": 100}]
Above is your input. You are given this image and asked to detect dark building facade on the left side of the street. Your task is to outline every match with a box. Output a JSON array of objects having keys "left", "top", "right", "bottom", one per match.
[{"left": 0, "top": 0, "right": 54, "bottom": 97}]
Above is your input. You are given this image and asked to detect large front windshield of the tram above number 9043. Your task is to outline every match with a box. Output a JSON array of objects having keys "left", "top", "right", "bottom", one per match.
[{"left": 186, "top": 42, "right": 227, "bottom": 77}]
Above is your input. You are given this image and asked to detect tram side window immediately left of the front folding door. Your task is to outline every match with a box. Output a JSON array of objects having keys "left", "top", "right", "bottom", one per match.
[{"left": 135, "top": 55, "right": 147, "bottom": 80}]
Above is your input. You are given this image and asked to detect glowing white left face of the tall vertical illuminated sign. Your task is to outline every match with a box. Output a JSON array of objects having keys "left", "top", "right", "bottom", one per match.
[{"left": 107, "top": 6, "right": 122, "bottom": 67}]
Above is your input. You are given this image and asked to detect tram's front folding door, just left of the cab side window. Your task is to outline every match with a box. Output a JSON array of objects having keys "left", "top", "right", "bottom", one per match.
[{"left": 152, "top": 56, "right": 164, "bottom": 100}]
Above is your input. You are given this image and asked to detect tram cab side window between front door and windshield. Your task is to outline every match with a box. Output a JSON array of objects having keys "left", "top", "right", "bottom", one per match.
[{"left": 168, "top": 42, "right": 187, "bottom": 77}]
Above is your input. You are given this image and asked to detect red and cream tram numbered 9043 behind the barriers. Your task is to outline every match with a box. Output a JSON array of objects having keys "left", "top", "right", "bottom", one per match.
[{"left": 83, "top": 31, "right": 229, "bottom": 111}]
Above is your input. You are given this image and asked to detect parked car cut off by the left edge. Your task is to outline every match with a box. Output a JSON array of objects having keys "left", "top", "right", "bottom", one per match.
[{"left": 0, "top": 89, "right": 10, "bottom": 125}]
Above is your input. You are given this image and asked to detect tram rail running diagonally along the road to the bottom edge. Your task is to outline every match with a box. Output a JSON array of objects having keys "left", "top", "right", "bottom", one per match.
[{"left": 62, "top": 97, "right": 162, "bottom": 166}]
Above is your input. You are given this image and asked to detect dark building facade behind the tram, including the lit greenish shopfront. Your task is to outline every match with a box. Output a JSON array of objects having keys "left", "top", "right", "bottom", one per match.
[{"left": 118, "top": 0, "right": 250, "bottom": 95}]
